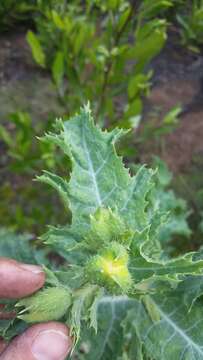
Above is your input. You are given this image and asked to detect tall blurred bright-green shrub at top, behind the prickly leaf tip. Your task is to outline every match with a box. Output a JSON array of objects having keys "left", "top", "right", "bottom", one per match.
[{"left": 27, "top": 0, "right": 170, "bottom": 127}]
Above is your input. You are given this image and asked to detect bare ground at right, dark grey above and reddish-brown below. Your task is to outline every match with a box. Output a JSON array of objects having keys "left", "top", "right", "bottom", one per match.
[{"left": 142, "top": 34, "right": 203, "bottom": 174}]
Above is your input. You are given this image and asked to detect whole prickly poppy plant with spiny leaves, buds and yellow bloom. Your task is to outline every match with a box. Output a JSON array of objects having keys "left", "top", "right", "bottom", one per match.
[{"left": 0, "top": 105, "right": 203, "bottom": 360}]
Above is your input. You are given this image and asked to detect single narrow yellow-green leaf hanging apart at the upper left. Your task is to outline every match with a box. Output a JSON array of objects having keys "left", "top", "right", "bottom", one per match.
[{"left": 26, "top": 30, "right": 46, "bottom": 67}]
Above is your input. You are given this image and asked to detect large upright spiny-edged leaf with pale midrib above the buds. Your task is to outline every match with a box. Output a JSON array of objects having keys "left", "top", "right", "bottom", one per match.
[{"left": 39, "top": 107, "right": 153, "bottom": 231}]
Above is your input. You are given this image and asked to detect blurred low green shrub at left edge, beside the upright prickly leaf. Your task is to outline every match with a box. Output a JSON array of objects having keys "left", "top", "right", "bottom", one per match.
[{"left": 0, "top": 111, "right": 69, "bottom": 234}]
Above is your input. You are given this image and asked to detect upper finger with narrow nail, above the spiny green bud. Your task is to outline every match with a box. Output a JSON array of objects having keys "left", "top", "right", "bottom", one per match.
[{"left": 0, "top": 258, "right": 45, "bottom": 299}]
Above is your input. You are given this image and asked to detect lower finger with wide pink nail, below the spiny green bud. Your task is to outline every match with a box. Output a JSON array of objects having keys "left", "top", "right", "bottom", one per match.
[{"left": 0, "top": 322, "right": 72, "bottom": 360}]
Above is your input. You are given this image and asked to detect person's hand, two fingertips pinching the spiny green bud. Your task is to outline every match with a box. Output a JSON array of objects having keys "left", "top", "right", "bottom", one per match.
[{"left": 0, "top": 258, "right": 71, "bottom": 360}]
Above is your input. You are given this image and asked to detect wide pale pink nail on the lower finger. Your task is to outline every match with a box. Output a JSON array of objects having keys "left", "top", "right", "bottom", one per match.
[{"left": 31, "top": 330, "right": 71, "bottom": 360}]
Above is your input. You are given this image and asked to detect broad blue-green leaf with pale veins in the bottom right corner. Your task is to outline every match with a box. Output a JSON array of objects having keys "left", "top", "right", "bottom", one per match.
[{"left": 131, "top": 296, "right": 203, "bottom": 360}]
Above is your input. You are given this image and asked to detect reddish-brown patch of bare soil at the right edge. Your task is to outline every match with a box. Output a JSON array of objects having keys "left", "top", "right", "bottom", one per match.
[{"left": 144, "top": 79, "right": 203, "bottom": 173}]
